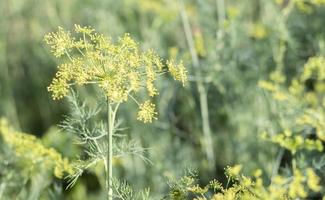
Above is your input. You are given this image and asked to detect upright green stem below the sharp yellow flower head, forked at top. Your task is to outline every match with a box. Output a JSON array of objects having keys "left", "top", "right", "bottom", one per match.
[{"left": 105, "top": 101, "right": 119, "bottom": 200}]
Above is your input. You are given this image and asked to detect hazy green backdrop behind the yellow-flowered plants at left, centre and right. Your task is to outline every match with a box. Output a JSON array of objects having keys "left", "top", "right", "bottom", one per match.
[{"left": 0, "top": 0, "right": 325, "bottom": 199}]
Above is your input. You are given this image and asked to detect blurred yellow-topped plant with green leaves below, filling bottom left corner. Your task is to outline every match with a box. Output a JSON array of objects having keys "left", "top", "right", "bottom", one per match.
[{"left": 0, "top": 118, "right": 73, "bottom": 199}]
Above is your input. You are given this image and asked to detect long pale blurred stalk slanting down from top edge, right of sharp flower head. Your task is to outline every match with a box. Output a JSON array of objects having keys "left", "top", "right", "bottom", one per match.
[{"left": 179, "top": 0, "right": 215, "bottom": 167}]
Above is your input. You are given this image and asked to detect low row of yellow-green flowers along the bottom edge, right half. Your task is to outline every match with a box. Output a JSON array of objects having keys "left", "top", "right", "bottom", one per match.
[{"left": 171, "top": 165, "right": 321, "bottom": 200}]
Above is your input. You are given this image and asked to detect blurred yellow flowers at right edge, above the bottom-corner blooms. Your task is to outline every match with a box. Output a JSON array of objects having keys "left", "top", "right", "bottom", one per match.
[{"left": 259, "top": 56, "right": 325, "bottom": 154}]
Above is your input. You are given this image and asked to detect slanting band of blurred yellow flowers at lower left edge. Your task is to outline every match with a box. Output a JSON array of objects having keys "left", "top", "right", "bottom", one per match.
[{"left": 0, "top": 119, "right": 73, "bottom": 178}]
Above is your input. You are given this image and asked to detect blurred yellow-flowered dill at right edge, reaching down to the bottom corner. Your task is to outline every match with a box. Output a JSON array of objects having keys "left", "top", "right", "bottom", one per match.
[{"left": 259, "top": 55, "right": 325, "bottom": 198}]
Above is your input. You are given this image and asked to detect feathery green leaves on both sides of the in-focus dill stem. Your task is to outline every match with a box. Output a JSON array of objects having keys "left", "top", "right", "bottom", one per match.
[{"left": 60, "top": 92, "right": 149, "bottom": 187}]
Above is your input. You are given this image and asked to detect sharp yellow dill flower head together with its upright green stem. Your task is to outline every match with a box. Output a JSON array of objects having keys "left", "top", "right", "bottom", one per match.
[{"left": 44, "top": 25, "right": 187, "bottom": 199}]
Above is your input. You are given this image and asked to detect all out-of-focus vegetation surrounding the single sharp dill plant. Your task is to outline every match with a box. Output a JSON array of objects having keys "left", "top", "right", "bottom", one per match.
[{"left": 0, "top": 0, "right": 325, "bottom": 200}]
